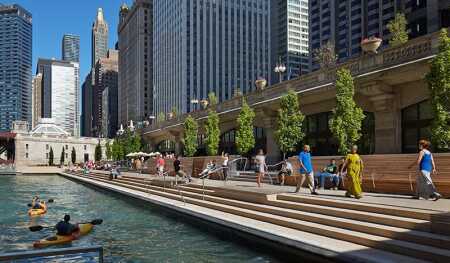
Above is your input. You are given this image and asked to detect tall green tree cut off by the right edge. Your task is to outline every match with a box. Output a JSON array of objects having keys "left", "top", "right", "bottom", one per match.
[{"left": 426, "top": 29, "right": 450, "bottom": 150}]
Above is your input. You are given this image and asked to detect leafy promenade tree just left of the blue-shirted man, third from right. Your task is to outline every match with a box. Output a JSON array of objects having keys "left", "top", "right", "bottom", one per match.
[{"left": 275, "top": 90, "right": 305, "bottom": 158}]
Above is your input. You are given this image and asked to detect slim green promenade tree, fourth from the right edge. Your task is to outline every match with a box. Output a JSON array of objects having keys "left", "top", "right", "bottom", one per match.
[{"left": 236, "top": 98, "right": 255, "bottom": 155}]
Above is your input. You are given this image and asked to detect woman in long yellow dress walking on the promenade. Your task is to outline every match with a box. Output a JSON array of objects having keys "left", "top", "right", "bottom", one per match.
[{"left": 341, "top": 145, "right": 364, "bottom": 199}]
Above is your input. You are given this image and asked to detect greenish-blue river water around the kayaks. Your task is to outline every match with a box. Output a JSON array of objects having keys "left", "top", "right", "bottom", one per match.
[{"left": 0, "top": 175, "right": 284, "bottom": 262}]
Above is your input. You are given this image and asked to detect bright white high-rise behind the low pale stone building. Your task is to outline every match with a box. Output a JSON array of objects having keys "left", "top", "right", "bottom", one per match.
[{"left": 36, "top": 59, "right": 80, "bottom": 136}]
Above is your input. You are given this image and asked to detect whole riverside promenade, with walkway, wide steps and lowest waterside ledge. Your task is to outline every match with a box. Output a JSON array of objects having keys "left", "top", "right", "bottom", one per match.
[{"left": 61, "top": 171, "right": 450, "bottom": 262}]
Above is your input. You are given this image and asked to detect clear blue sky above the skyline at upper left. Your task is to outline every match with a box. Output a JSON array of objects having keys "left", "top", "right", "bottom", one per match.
[{"left": 8, "top": 0, "right": 132, "bottom": 80}]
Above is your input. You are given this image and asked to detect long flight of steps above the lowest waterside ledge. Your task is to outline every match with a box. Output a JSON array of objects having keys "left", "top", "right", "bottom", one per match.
[{"left": 71, "top": 174, "right": 450, "bottom": 262}]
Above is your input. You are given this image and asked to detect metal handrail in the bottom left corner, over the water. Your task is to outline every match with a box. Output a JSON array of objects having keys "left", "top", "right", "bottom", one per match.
[{"left": 0, "top": 246, "right": 103, "bottom": 263}]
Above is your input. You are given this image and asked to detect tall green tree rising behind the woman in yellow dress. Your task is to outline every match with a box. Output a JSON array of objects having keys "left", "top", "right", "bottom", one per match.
[{"left": 330, "top": 69, "right": 365, "bottom": 154}]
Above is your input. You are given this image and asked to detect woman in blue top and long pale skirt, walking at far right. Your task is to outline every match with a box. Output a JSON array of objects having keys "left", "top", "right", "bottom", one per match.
[{"left": 409, "top": 140, "right": 442, "bottom": 201}]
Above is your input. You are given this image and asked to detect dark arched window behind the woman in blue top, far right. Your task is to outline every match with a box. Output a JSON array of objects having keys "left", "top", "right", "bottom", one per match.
[{"left": 402, "top": 100, "right": 433, "bottom": 153}]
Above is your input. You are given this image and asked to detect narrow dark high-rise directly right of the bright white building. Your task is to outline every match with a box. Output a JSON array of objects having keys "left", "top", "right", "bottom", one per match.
[{"left": 81, "top": 73, "right": 93, "bottom": 137}]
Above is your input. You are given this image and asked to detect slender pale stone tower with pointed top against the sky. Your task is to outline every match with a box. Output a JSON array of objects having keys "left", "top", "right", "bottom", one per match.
[{"left": 91, "top": 8, "right": 108, "bottom": 68}]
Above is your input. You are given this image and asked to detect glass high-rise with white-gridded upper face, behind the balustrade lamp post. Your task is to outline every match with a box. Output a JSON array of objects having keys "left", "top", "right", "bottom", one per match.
[{"left": 271, "top": 0, "right": 309, "bottom": 83}]
